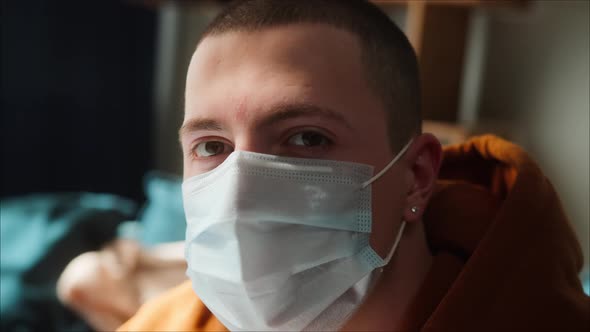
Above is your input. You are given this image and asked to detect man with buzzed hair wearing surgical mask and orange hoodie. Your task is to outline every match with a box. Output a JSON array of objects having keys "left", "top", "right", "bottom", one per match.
[{"left": 121, "top": 0, "right": 590, "bottom": 331}]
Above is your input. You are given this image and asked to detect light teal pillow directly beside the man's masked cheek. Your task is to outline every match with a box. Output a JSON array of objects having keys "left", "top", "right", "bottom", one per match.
[{"left": 139, "top": 171, "right": 186, "bottom": 246}]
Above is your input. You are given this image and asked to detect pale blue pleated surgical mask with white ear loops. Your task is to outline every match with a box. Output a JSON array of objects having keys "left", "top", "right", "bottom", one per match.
[{"left": 183, "top": 142, "right": 411, "bottom": 331}]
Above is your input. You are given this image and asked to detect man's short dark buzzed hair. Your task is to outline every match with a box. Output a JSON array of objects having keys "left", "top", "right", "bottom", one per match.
[{"left": 201, "top": 0, "right": 422, "bottom": 152}]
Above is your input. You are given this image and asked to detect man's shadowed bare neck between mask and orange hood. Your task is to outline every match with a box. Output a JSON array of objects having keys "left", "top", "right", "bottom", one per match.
[{"left": 342, "top": 221, "right": 432, "bottom": 331}]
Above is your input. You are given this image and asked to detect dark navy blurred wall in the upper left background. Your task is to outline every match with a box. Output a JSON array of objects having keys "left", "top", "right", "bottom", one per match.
[{"left": 0, "top": 0, "right": 157, "bottom": 199}]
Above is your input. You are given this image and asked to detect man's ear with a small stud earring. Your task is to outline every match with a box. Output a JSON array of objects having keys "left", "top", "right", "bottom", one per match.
[{"left": 403, "top": 134, "right": 442, "bottom": 222}]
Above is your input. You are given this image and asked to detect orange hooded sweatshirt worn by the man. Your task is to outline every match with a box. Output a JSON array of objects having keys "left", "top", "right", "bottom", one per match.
[{"left": 119, "top": 136, "right": 590, "bottom": 332}]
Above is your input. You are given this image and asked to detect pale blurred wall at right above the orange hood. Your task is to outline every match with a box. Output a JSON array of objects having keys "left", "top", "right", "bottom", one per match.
[{"left": 476, "top": 1, "right": 590, "bottom": 267}]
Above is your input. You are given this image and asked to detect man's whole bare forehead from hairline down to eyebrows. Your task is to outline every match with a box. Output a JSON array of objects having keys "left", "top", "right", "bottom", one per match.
[{"left": 185, "top": 24, "right": 380, "bottom": 130}]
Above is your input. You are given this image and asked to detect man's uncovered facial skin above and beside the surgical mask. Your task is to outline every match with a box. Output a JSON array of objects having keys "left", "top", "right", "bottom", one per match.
[{"left": 181, "top": 24, "right": 406, "bottom": 256}]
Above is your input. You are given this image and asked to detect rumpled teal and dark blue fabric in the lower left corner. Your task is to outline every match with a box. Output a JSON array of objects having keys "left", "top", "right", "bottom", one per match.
[{"left": 0, "top": 193, "right": 136, "bottom": 331}]
